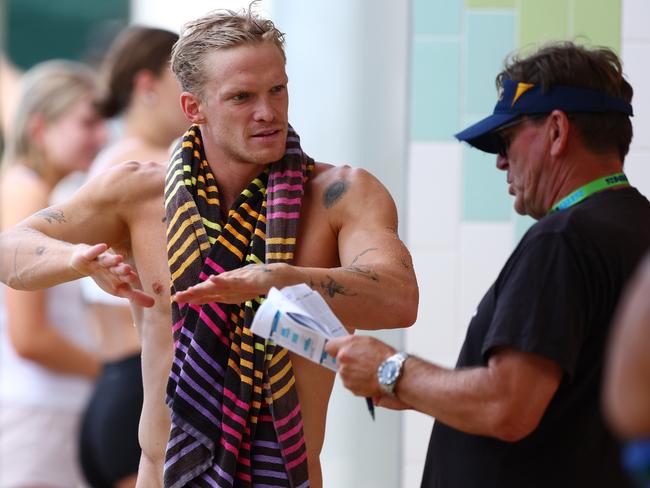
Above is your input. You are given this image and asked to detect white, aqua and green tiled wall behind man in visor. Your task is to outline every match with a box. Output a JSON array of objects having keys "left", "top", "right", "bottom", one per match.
[{"left": 402, "top": 0, "right": 650, "bottom": 488}]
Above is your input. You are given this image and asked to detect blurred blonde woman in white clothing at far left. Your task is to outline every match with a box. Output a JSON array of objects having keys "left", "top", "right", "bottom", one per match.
[{"left": 0, "top": 61, "right": 106, "bottom": 487}]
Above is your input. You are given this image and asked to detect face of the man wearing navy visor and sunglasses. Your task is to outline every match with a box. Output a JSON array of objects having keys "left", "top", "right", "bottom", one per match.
[{"left": 497, "top": 118, "right": 550, "bottom": 219}]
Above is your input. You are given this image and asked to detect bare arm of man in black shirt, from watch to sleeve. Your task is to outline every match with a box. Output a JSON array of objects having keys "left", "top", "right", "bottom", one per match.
[{"left": 396, "top": 348, "right": 563, "bottom": 441}]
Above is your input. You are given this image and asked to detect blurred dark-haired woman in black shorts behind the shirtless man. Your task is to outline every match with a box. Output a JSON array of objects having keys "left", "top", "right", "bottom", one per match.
[{"left": 80, "top": 26, "right": 187, "bottom": 488}]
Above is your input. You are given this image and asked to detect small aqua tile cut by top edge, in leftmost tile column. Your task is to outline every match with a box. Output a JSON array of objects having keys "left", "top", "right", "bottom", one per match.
[{"left": 412, "top": 0, "right": 463, "bottom": 35}]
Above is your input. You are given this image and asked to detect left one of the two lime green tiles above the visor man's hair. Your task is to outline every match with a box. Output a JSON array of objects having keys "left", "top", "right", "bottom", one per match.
[{"left": 519, "top": 0, "right": 570, "bottom": 49}]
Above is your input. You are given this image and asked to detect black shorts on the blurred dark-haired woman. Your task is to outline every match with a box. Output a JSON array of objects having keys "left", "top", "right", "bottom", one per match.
[{"left": 79, "top": 354, "right": 143, "bottom": 488}]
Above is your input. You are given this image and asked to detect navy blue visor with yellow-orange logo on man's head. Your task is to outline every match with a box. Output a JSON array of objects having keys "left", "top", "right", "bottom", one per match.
[{"left": 456, "top": 79, "right": 633, "bottom": 154}]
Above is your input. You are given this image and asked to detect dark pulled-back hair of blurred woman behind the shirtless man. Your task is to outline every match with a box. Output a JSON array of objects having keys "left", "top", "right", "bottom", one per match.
[{"left": 96, "top": 26, "right": 178, "bottom": 118}]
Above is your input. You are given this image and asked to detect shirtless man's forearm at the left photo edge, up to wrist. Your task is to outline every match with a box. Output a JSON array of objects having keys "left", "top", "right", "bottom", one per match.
[{"left": 0, "top": 227, "right": 82, "bottom": 290}]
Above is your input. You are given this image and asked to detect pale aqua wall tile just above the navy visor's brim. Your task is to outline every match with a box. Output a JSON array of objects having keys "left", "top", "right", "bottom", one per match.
[{"left": 464, "top": 11, "right": 516, "bottom": 113}]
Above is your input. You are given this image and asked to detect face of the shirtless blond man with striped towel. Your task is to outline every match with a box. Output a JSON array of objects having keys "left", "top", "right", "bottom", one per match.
[{"left": 194, "top": 42, "right": 289, "bottom": 168}]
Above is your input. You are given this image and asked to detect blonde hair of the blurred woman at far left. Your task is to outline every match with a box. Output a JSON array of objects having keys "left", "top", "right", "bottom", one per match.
[{"left": 4, "top": 60, "right": 97, "bottom": 173}]
